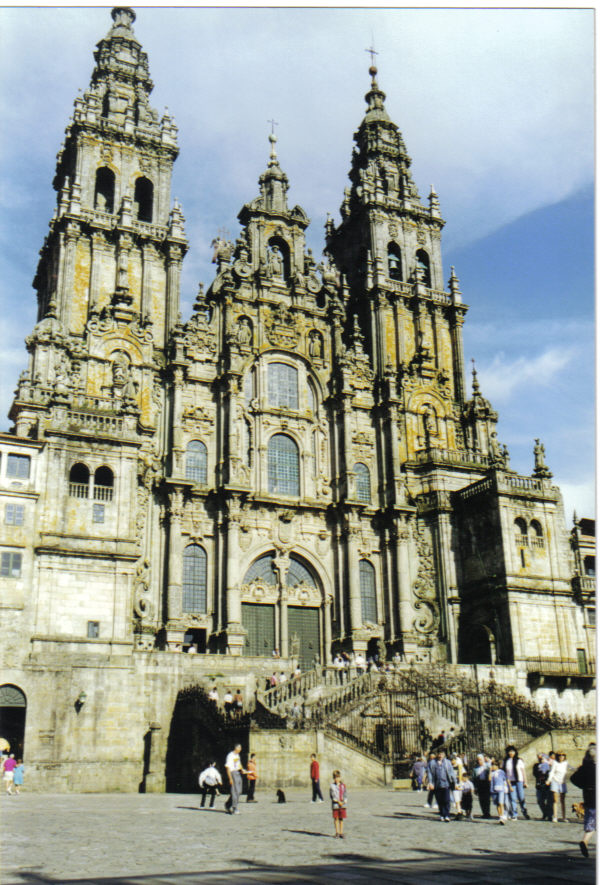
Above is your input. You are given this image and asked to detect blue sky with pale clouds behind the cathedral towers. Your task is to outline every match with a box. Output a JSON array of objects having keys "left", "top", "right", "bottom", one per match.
[{"left": 0, "top": 7, "right": 594, "bottom": 521}]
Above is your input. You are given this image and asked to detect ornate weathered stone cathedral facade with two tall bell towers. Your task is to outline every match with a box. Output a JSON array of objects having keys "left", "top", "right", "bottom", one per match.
[{"left": 0, "top": 7, "right": 594, "bottom": 783}]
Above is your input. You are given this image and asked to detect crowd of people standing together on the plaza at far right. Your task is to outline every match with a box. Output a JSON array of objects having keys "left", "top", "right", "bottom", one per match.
[{"left": 411, "top": 744, "right": 596, "bottom": 856}]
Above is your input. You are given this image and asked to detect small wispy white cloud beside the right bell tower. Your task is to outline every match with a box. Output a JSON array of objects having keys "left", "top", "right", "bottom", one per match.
[{"left": 478, "top": 347, "right": 577, "bottom": 403}]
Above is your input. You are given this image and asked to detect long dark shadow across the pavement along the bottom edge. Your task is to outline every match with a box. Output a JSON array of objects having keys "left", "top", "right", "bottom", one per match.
[{"left": 7, "top": 844, "right": 595, "bottom": 885}]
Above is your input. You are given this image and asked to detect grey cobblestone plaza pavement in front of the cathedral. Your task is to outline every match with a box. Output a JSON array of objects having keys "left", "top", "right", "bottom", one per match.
[{"left": 0, "top": 787, "right": 596, "bottom": 885}]
